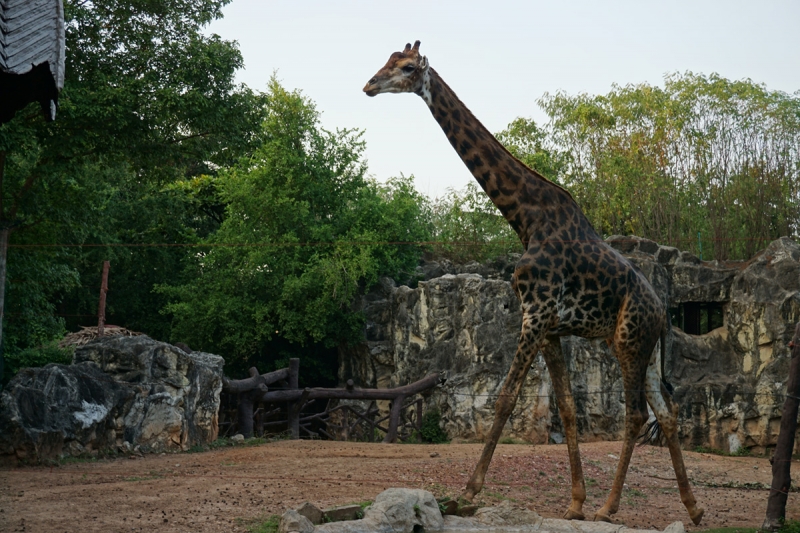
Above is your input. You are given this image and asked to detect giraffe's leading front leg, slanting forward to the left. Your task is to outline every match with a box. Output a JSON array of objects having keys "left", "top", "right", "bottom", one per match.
[{"left": 462, "top": 320, "right": 541, "bottom": 502}]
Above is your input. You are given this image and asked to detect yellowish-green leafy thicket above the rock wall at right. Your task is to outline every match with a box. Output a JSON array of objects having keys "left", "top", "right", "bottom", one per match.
[{"left": 540, "top": 74, "right": 800, "bottom": 260}]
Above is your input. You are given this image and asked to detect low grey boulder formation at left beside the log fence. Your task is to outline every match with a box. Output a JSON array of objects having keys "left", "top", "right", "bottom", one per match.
[{"left": 0, "top": 335, "right": 224, "bottom": 462}]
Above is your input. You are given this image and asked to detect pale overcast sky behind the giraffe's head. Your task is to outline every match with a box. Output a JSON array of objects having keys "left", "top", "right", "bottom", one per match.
[{"left": 209, "top": 0, "right": 800, "bottom": 196}]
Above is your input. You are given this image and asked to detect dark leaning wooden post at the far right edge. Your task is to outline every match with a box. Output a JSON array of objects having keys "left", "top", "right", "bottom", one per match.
[{"left": 761, "top": 323, "right": 800, "bottom": 531}]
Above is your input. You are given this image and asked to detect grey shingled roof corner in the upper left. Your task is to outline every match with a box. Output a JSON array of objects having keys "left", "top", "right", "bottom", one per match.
[{"left": 0, "top": 0, "right": 64, "bottom": 124}]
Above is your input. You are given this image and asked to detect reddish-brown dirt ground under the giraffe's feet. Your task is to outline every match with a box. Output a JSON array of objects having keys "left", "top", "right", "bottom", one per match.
[{"left": 0, "top": 441, "right": 800, "bottom": 533}]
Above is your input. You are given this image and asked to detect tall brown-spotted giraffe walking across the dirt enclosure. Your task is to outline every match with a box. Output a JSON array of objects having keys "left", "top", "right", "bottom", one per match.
[{"left": 364, "top": 41, "right": 704, "bottom": 524}]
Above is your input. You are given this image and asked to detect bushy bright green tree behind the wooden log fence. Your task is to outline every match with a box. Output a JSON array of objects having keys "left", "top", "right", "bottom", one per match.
[{"left": 159, "top": 78, "right": 428, "bottom": 380}]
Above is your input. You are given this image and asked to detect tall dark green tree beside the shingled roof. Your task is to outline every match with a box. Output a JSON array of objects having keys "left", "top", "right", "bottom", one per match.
[{"left": 0, "top": 0, "right": 263, "bottom": 378}]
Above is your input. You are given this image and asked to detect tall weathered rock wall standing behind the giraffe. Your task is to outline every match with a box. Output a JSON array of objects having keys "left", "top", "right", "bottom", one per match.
[{"left": 339, "top": 236, "right": 800, "bottom": 452}]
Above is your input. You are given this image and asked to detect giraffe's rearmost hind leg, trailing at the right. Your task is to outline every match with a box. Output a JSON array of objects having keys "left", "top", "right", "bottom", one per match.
[{"left": 646, "top": 355, "right": 705, "bottom": 525}]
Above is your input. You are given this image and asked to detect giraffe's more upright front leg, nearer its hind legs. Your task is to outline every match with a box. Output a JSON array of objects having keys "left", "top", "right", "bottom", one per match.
[{"left": 542, "top": 338, "right": 586, "bottom": 520}]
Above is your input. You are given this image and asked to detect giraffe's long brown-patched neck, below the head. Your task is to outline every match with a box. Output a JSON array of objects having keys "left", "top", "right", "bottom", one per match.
[{"left": 417, "top": 68, "right": 599, "bottom": 248}]
